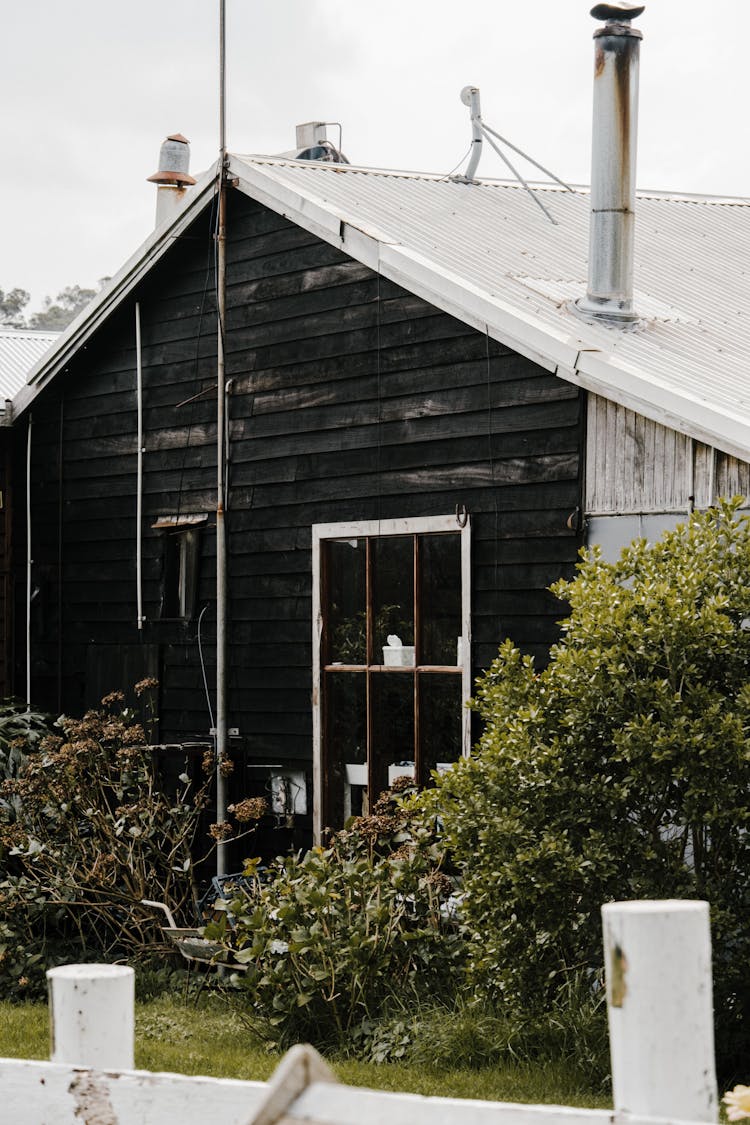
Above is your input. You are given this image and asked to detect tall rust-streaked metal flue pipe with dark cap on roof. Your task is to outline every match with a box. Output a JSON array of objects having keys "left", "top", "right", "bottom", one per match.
[{"left": 573, "top": 2, "right": 644, "bottom": 325}]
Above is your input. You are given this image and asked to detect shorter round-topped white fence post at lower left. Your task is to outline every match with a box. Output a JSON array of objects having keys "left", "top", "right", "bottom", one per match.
[{"left": 47, "top": 965, "right": 135, "bottom": 1070}]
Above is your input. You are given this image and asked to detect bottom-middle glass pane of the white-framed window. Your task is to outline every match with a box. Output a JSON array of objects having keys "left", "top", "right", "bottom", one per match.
[{"left": 370, "top": 672, "right": 414, "bottom": 797}]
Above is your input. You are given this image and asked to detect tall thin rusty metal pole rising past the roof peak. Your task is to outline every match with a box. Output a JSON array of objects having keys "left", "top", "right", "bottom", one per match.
[{"left": 216, "top": 0, "right": 227, "bottom": 875}]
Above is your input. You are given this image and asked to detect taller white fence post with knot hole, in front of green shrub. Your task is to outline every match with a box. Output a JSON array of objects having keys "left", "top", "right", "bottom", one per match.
[{"left": 602, "top": 900, "right": 717, "bottom": 1122}]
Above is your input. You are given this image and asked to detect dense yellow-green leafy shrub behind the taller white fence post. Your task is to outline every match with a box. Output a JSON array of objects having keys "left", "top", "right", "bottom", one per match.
[{"left": 431, "top": 504, "right": 750, "bottom": 1070}]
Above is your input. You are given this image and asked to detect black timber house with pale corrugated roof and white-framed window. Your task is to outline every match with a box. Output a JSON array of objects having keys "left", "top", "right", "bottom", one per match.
[{"left": 3, "top": 149, "right": 750, "bottom": 842}]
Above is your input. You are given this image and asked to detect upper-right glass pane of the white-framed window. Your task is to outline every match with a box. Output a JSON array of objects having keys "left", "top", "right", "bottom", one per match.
[{"left": 419, "top": 534, "right": 461, "bottom": 666}]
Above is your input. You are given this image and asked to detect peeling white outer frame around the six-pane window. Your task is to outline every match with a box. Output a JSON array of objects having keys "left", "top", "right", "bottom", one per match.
[{"left": 313, "top": 514, "right": 471, "bottom": 843}]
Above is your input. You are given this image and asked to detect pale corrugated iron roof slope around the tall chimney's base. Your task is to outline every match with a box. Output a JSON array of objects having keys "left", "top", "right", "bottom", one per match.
[{"left": 240, "top": 158, "right": 750, "bottom": 456}]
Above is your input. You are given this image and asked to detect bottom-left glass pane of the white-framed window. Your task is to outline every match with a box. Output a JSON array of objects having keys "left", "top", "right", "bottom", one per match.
[{"left": 323, "top": 672, "right": 368, "bottom": 828}]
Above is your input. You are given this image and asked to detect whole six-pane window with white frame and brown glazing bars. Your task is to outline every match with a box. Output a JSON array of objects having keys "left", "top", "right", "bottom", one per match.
[{"left": 314, "top": 516, "right": 470, "bottom": 831}]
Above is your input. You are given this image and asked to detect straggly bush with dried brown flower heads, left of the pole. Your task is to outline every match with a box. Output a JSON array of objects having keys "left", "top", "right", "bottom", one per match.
[{"left": 0, "top": 681, "right": 209, "bottom": 996}]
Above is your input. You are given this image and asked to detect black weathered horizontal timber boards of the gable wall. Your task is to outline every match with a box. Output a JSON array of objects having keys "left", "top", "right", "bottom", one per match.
[{"left": 16, "top": 186, "right": 584, "bottom": 801}]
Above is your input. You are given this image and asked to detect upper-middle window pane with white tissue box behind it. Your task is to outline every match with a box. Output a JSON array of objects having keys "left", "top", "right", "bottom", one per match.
[{"left": 370, "top": 536, "right": 414, "bottom": 667}]
